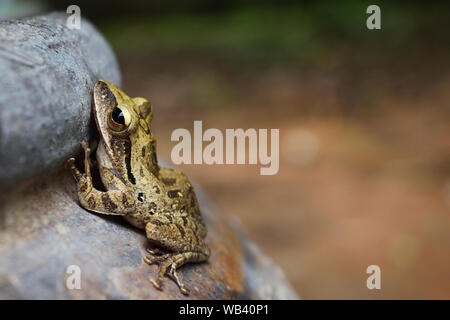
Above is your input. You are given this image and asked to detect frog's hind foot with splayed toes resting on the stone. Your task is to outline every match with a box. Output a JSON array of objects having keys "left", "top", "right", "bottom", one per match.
[{"left": 150, "top": 252, "right": 192, "bottom": 296}]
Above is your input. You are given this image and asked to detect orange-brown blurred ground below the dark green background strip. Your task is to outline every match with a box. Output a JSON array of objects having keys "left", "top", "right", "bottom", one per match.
[{"left": 120, "top": 51, "right": 450, "bottom": 299}]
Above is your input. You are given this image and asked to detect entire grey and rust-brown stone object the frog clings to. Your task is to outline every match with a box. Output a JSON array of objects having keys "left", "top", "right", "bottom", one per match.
[{"left": 0, "top": 14, "right": 297, "bottom": 299}]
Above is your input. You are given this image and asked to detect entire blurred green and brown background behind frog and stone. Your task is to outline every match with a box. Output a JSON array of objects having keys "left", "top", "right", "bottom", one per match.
[{"left": 0, "top": 0, "right": 450, "bottom": 299}]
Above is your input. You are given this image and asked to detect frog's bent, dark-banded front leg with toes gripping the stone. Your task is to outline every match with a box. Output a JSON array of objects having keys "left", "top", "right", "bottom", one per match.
[{"left": 66, "top": 141, "right": 134, "bottom": 215}]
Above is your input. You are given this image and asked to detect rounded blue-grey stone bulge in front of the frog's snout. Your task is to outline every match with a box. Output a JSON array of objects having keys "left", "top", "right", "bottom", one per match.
[{"left": 0, "top": 13, "right": 121, "bottom": 188}]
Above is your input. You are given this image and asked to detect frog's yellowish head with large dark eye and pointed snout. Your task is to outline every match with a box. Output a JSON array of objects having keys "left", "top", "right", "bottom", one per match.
[{"left": 94, "top": 80, "right": 154, "bottom": 169}]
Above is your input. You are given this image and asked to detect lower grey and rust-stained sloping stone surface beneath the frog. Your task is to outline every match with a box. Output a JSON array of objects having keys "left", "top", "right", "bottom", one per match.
[{"left": 0, "top": 171, "right": 297, "bottom": 299}]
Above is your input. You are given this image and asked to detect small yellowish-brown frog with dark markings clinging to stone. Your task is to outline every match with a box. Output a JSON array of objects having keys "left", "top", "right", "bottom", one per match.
[{"left": 65, "top": 80, "right": 211, "bottom": 295}]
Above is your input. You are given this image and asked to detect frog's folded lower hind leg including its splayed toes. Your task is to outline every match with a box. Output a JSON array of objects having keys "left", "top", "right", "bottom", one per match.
[{"left": 150, "top": 252, "right": 208, "bottom": 295}]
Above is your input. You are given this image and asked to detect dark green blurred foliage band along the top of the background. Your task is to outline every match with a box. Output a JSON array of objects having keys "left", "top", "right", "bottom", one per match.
[{"left": 50, "top": 0, "right": 450, "bottom": 67}]
